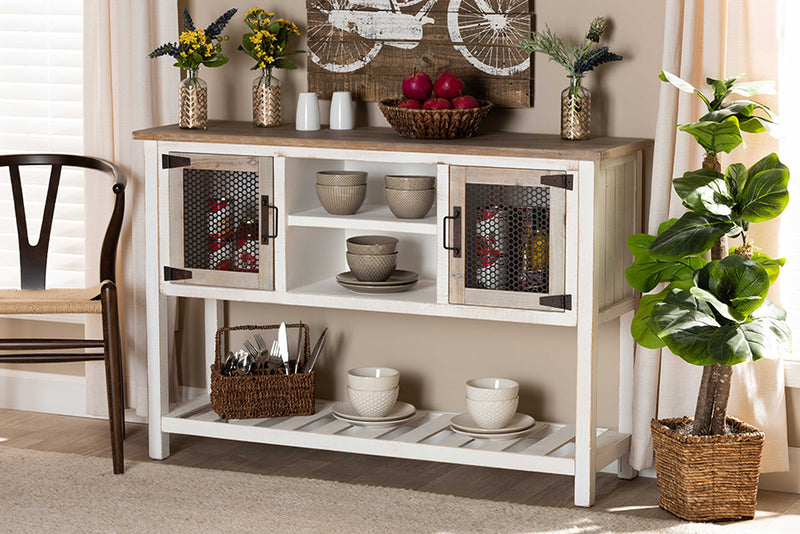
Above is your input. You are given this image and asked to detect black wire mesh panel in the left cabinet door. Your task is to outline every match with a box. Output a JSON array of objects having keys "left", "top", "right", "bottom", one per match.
[{"left": 183, "top": 169, "right": 258, "bottom": 272}]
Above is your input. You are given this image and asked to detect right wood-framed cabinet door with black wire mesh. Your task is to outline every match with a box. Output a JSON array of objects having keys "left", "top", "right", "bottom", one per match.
[{"left": 444, "top": 167, "right": 572, "bottom": 311}]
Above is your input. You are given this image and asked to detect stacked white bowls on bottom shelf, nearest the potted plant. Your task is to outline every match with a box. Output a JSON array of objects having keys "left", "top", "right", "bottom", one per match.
[{"left": 467, "top": 378, "right": 519, "bottom": 429}]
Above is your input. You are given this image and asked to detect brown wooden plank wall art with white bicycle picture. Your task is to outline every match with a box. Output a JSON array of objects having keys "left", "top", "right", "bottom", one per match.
[{"left": 306, "top": 0, "right": 533, "bottom": 107}]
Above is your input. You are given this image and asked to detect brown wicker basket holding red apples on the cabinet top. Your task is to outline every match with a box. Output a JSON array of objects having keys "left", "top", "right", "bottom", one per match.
[{"left": 378, "top": 99, "right": 494, "bottom": 139}]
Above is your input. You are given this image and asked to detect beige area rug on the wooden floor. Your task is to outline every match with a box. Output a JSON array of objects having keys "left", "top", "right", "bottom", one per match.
[{"left": 0, "top": 447, "right": 742, "bottom": 534}]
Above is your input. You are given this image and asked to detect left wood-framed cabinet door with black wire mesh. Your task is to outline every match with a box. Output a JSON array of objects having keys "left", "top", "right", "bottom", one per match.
[{"left": 162, "top": 152, "right": 277, "bottom": 289}]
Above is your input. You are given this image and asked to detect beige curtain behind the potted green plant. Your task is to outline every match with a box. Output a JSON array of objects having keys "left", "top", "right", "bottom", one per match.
[{"left": 631, "top": 0, "right": 789, "bottom": 472}]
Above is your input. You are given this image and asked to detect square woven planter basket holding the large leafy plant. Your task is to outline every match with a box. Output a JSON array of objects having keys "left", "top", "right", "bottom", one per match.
[{"left": 650, "top": 417, "right": 764, "bottom": 521}]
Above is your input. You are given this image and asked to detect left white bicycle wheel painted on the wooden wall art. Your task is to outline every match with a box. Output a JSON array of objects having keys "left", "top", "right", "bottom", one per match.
[{"left": 308, "top": 0, "right": 383, "bottom": 72}]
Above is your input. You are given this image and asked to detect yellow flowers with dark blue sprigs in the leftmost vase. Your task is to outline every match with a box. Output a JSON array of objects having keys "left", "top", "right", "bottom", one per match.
[{"left": 148, "top": 9, "right": 236, "bottom": 69}]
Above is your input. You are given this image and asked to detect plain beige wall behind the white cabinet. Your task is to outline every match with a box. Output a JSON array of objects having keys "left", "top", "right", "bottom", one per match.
[{"left": 172, "top": 0, "right": 663, "bottom": 426}]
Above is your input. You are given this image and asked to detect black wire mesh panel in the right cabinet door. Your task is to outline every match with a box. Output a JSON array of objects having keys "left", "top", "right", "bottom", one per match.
[{"left": 464, "top": 184, "right": 550, "bottom": 293}]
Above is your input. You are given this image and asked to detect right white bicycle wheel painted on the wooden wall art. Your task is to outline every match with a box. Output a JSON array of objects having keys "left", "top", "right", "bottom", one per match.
[{"left": 447, "top": 0, "right": 531, "bottom": 76}]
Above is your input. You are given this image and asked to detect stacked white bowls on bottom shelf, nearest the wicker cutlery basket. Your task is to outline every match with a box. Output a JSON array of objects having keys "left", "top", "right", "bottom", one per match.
[{"left": 347, "top": 367, "right": 400, "bottom": 417}]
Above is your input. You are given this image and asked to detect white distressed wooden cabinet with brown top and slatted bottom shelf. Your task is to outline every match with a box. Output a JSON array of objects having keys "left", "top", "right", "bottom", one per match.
[{"left": 133, "top": 121, "right": 652, "bottom": 506}]
